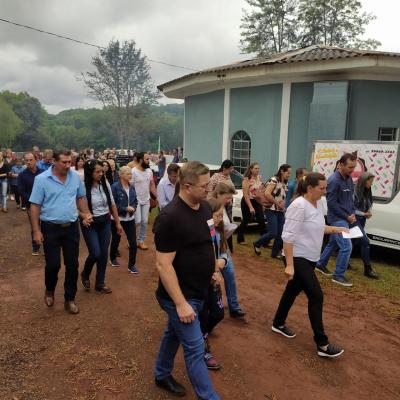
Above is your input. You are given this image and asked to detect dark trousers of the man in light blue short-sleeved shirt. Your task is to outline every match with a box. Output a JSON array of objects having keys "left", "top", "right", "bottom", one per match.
[{"left": 41, "top": 221, "right": 79, "bottom": 301}]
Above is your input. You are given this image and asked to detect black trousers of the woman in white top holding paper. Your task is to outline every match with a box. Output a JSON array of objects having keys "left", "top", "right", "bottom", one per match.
[{"left": 273, "top": 257, "right": 329, "bottom": 346}]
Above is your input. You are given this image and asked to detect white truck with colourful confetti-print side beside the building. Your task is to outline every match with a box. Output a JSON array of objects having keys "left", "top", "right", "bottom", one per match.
[{"left": 312, "top": 140, "right": 400, "bottom": 250}]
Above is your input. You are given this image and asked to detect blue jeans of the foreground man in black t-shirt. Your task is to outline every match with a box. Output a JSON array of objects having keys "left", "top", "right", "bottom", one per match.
[{"left": 154, "top": 296, "right": 220, "bottom": 400}]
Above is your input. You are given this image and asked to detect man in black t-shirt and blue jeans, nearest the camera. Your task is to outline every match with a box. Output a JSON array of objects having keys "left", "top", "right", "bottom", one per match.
[{"left": 154, "top": 161, "right": 224, "bottom": 400}]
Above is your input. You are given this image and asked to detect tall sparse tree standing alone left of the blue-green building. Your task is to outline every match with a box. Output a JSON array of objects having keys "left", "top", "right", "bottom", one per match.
[{"left": 82, "top": 40, "right": 159, "bottom": 148}]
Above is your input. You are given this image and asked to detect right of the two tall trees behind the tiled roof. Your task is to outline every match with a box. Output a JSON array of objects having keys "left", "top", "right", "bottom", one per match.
[{"left": 299, "top": 0, "right": 381, "bottom": 49}]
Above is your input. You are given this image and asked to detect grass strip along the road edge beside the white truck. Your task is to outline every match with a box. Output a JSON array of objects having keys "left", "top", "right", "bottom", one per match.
[{"left": 234, "top": 228, "right": 400, "bottom": 302}]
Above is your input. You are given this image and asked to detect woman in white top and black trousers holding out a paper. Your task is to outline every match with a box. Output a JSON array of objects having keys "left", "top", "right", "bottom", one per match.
[{"left": 272, "top": 172, "right": 349, "bottom": 358}]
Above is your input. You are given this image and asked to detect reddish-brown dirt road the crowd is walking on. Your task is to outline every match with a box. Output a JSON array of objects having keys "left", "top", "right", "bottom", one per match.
[{"left": 0, "top": 211, "right": 400, "bottom": 400}]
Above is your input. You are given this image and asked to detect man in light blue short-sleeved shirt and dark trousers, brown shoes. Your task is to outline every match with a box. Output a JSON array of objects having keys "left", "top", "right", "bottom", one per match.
[{"left": 29, "top": 150, "right": 92, "bottom": 314}]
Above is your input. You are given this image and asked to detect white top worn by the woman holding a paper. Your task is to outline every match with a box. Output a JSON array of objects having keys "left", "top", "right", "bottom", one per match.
[{"left": 282, "top": 197, "right": 325, "bottom": 262}]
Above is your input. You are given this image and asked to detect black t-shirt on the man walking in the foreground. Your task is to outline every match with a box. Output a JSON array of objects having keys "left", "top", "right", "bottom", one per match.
[{"left": 153, "top": 196, "right": 215, "bottom": 300}]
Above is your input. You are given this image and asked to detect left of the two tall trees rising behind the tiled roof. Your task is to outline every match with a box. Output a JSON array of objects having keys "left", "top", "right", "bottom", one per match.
[{"left": 240, "top": 0, "right": 298, "bottom": 56}]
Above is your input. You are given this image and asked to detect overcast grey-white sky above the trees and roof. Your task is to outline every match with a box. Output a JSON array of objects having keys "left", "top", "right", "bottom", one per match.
[{"left": 0, "top": 0, "right": 400, "bottom": 113}]
